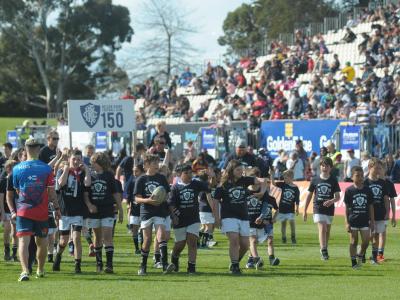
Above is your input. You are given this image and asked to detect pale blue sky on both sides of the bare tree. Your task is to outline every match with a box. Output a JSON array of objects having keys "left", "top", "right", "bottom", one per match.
[{"left": 113, "top": 0, "right": 250, "bottom": 69}]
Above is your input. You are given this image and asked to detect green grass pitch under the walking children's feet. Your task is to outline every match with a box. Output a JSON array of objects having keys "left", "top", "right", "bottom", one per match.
[{"left": 0, "top": 213, "right": 400, "bottom": 300}]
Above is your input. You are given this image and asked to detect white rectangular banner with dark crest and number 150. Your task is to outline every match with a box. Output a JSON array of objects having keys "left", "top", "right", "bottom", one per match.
[{"left": 68, "top": 100, "right": 136, "bottom": 132}]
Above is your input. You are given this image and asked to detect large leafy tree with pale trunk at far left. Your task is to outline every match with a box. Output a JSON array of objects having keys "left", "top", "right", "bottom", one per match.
[{"left": 0, "top": 0, "right": 133, "bottom": 112}]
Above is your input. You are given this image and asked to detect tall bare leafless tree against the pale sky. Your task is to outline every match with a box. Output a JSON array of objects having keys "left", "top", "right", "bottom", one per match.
[{"left": 124, "top": 0, "right": 197, "bottom": 82}]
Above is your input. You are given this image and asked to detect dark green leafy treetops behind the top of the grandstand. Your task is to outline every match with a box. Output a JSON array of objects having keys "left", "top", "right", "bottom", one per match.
[{"left": 218, "top": 0, "right": 337, "bottom": 53}]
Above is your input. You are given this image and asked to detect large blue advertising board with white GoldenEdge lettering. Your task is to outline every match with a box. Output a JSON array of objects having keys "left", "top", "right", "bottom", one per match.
[{"left": 260, "top": 120, "right": 343, "bottom": 157}]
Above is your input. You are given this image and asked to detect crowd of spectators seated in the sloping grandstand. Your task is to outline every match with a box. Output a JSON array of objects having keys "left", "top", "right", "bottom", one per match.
[{"left": 123, "top": 4, "right": 400, "bottom": 128}]
